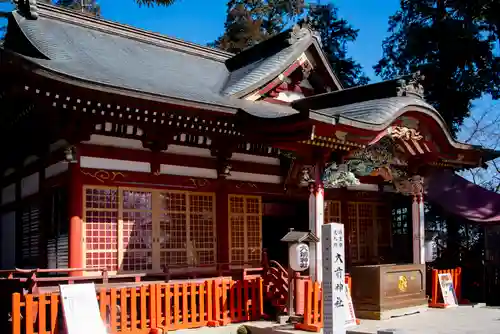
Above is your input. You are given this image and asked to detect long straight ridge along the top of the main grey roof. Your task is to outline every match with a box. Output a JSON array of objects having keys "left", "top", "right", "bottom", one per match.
[{"left": 33, "top": 3, "right": 233, "bottom": 62}]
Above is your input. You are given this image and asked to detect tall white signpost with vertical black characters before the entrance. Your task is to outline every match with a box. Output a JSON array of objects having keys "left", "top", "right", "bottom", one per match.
[{"left": 322, "top": 223, "right": 348, "bottom": 334}]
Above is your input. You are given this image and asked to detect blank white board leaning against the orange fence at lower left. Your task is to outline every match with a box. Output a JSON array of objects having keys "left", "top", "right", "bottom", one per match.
[{"left": 59, "top": 283, "right": 107, "bottom": 334}]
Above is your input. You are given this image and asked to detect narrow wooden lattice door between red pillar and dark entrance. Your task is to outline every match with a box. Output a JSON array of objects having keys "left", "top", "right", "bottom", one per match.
[{"left": 229, "top": 195, "right": 262, "bottom": 265}]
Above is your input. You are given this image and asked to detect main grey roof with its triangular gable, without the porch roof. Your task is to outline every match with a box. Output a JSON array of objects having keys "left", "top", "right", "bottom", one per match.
[{"left": 7, "top": 4, "right": 340, "bottom": 107}]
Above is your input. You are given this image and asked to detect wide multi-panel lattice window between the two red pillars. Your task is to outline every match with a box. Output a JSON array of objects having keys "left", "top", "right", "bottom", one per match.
[{"left": 83, "top": 187, "right": 217, "bottom": 272}]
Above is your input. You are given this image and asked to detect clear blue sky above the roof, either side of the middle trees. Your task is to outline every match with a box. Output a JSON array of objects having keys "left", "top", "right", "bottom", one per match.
[{"left": 100, "top": 0, "right": 399, "bottom": 79}]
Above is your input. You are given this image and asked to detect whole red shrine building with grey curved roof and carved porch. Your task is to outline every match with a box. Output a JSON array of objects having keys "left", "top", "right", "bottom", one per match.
[{"left": 0, "top": 2, "right": 499, "bottom": 288}]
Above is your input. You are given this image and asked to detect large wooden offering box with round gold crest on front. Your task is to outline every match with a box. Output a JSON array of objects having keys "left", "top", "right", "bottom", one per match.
[{"left": 350, "top": 264, "right": 428, "bottom": 320}]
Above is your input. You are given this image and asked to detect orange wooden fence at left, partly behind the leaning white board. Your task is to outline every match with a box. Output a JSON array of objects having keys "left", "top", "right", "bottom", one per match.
[{"left": 11, "top": 278, "right": 263, "bottom": 334}]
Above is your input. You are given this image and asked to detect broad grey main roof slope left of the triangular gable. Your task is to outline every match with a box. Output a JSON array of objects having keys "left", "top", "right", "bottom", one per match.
[{"left": 6, "top": 6, "right": 297, "bottom": 118}]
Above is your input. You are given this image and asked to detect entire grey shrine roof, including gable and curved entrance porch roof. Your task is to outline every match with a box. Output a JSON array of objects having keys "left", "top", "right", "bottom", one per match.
[{"left": 7, "top": 4, "right": 496, "bottom": 164}]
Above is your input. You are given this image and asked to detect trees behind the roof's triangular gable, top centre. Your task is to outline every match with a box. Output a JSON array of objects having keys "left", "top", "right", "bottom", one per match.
[{"left": 209, "top": 0, "right": 368, "bottom": 87}]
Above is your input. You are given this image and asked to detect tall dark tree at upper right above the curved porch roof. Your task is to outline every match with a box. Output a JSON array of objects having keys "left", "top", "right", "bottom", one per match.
[{"left": 374, "top": 0, "right": 500, "bottom": 133}]
